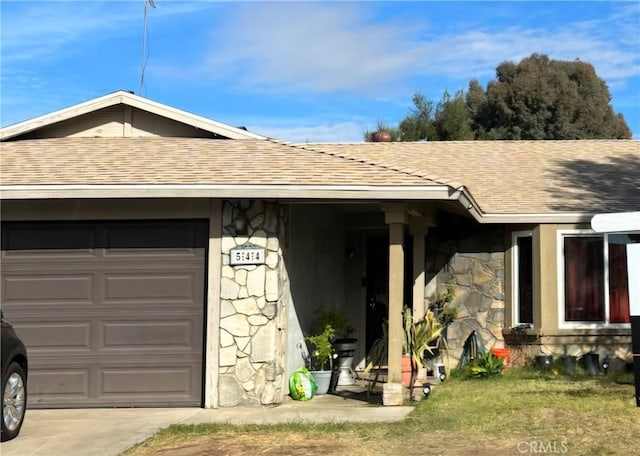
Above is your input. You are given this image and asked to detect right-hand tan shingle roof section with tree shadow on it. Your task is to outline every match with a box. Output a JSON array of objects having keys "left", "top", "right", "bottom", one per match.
[{"left": 298, "top": 140, "right": 640, "bottom": 213}]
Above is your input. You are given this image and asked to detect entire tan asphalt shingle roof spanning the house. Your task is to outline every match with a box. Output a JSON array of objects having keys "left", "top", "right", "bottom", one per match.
[{"left": 0, "top": 137, "right": 640, "bottom": 214}]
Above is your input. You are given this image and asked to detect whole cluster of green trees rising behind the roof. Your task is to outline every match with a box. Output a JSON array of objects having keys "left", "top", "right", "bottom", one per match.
[{"left": 365, "top": 54, "right": 631, "bottom": 141}]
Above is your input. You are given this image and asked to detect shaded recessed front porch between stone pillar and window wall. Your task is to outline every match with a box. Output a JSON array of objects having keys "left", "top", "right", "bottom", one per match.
[{"left": 283, "top": 202, "right": 504, "bottom": 404}]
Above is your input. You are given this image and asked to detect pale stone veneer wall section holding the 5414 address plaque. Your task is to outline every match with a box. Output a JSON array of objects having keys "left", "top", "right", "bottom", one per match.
[{"left": 219, "top": 200, "right": 290, "bottom": 407}]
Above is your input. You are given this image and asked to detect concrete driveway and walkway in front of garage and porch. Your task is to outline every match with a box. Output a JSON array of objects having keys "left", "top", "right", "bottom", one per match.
[{"left": 0, "top": 395, "right": 413, "bottom": 456}]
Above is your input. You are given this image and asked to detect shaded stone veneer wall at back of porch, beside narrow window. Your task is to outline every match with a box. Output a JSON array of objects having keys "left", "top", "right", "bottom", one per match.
[{"left": 425, "top": 218, "right": 505, "bottom": 369}]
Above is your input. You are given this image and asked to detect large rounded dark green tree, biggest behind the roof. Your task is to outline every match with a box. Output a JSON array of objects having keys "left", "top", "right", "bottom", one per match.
[{"left": 480, "top": 54, "right": 631, "bottom": 139}]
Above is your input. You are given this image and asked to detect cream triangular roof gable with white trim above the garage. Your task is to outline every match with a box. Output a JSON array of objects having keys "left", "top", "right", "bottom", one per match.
[{"left": 0, "top": 90, "right": 266, "bottom": 141}]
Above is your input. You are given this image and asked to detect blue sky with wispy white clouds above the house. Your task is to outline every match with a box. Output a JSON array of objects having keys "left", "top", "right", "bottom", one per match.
[{"left": 0, "top": 0, "right": 640, "bottom": 142}]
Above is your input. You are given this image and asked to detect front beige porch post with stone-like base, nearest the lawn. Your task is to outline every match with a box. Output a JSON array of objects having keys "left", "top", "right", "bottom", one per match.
[{"left": 383, "top": 207, "right": 407, "bottom": 405}]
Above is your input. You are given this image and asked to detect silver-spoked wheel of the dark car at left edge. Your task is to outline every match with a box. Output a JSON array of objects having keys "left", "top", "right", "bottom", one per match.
[{"left": 2, "top": 362, "right": 27, "bottom": 442}]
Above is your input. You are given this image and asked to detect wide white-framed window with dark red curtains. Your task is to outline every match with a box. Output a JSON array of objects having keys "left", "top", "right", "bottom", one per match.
[{"left": 558, "top": 230, "right": 630, "bottom": 328}]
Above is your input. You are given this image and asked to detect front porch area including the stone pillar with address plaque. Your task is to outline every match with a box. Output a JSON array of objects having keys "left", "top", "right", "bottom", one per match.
[{"left": 219, "top": 200, "right": 504, "bottom": 407}]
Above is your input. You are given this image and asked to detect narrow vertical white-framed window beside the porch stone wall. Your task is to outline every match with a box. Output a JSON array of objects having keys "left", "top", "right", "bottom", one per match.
[{"left": 511, "top": 231, "right": 534, "bottom": 326}]
